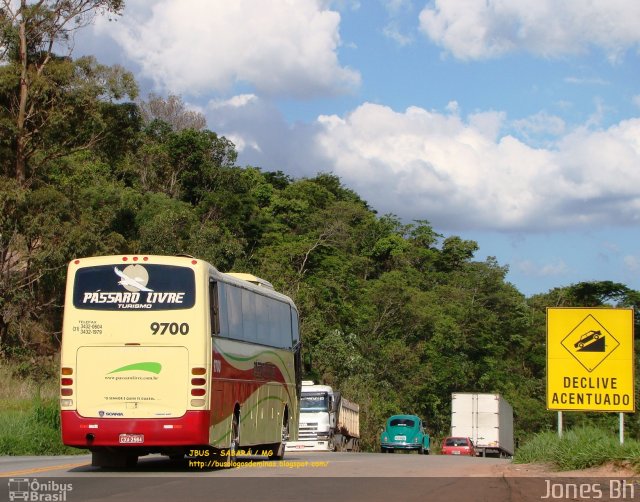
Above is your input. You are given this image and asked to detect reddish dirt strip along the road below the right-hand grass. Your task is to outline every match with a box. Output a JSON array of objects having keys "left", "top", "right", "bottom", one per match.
[{"left": 493, "top": 463, "right": 640, "bottom": 478}]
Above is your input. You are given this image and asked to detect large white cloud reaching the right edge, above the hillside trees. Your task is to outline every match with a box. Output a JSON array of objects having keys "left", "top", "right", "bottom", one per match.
[{"left": 315, "top": 103, "right": 640, "bottom": 231}]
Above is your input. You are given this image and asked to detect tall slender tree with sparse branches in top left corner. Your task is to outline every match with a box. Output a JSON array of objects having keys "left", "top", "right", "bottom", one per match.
[{"left": 0, "top": 0, "right": 127, "bottom": 184}]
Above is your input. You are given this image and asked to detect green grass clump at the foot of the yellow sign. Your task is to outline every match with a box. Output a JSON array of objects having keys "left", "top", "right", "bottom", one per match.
[{"left": 513, "top": 426, "right": 640, "bottom": 472}]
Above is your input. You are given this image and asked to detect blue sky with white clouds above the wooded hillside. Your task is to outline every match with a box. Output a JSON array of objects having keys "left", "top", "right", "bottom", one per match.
[{"left": 74, "top": 0, "right": 640, "bottom": 296}]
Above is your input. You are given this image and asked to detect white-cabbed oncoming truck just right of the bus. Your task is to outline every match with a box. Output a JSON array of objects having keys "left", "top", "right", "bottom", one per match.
[{"left": 286, "top": 380, "right": 360, "bottom": 451}]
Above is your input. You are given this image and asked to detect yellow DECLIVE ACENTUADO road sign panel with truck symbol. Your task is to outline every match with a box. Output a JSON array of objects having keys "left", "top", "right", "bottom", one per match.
[{"left": 547, "top": 308, "right": 635, "bottom": 412}]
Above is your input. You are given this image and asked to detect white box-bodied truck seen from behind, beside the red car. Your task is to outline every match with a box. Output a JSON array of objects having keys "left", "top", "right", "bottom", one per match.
[{"left": 451, "top": 392, "right": 513, "bottom": 457}]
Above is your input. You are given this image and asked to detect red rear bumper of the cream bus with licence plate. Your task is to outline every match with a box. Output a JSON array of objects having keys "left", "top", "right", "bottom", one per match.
[{"left": 60, "top": 410, "right": 210, "bottom": 451}]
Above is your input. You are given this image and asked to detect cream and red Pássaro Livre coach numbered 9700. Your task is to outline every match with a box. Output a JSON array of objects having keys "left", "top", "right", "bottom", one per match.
[{"left": 60, "top": 255, "right": 302, "bottom": 467}]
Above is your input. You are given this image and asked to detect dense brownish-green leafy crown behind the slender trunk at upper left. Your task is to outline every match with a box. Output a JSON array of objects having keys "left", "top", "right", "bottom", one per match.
[{"left": 0, "top": 51, "right": 139, "bottom": 178}]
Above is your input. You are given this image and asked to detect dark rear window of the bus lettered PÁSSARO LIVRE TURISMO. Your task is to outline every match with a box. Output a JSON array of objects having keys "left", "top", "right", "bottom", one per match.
[{"left": 73, "top": 264, "right": 195, "bottom": 310}]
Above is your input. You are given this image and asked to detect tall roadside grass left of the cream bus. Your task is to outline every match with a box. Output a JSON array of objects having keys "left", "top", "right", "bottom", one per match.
[{"left": 0, "top": 359, "right": 86, "bottom": 455}]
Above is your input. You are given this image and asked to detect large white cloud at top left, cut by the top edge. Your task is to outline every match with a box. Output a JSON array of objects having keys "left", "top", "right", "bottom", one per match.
[{"left": 96, "top": 0, "right": 360, "bottom": 97}]
